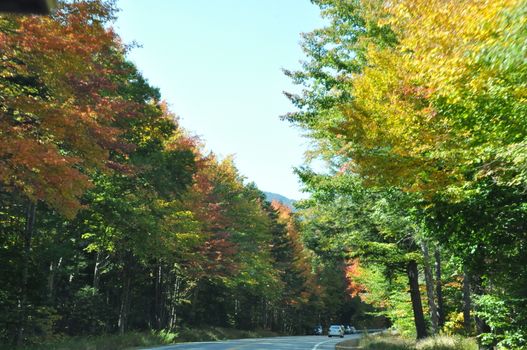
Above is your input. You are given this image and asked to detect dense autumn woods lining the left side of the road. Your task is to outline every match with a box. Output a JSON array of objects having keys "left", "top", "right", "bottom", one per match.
[{"left": 0, "top": 0, "right": 364, "bottom": 344}]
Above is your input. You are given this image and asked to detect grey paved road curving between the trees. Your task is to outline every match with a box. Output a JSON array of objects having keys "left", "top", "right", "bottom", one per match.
[{"left": 145, "top": 334, "right": 360, "bottom": 350}]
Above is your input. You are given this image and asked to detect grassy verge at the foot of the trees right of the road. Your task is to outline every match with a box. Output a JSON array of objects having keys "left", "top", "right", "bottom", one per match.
[{"left": 336, "top": 334, "right": 478, "bottom": 350}]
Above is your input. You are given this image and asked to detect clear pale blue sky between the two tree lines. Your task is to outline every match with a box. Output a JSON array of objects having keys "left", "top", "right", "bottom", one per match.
[{"left": 115, "top": 0, "right": 322, "bottom": 199}]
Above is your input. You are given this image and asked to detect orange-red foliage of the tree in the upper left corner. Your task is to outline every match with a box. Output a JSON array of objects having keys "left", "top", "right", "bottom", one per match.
[{"left": 0, "top": 1, "right": 137, "bottom": 217}]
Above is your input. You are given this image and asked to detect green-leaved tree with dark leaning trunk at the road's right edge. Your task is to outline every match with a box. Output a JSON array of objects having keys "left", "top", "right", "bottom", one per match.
[{"left": 300, "top": 171, "right": 427, "bottom": 338}]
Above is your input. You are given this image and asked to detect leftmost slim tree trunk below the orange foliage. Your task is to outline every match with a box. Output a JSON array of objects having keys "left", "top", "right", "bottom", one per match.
[{"left": 14, "top": 200, "right": 37, "bottom": 346}]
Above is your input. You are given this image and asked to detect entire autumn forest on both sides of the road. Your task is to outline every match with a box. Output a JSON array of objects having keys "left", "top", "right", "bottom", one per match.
[{"left": 0, "top": 0, "right": 527, "bottom": 349}]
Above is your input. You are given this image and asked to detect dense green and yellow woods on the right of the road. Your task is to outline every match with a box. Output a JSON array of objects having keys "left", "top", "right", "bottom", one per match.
[{"left": 285, "top": 0, "right": 527, "bottom": 349}]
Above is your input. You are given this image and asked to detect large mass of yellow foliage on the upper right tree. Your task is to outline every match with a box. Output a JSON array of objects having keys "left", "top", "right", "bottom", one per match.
[{"left": 337, "top": 0, "right": 527, "bottom": 196}]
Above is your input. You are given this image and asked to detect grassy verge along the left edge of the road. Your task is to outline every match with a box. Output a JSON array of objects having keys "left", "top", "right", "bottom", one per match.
[{"left": 0, "top": 327, "right": 278, "bottom": 350}]
